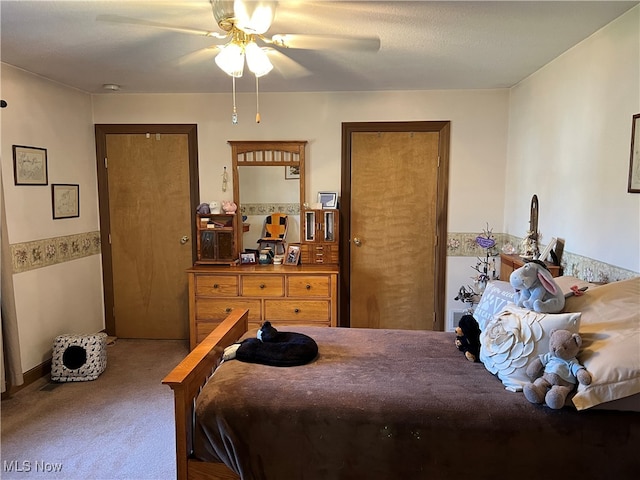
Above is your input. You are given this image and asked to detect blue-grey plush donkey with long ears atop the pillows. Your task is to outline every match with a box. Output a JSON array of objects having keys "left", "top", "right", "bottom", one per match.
[{"left": 509, "top": 260, "right": 564, "bottom": 313}]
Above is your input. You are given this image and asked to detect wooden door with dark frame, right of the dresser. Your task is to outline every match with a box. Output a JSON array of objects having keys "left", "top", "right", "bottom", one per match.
[{"left": 341, "top": 122, "right": 448, "bottom": 330}]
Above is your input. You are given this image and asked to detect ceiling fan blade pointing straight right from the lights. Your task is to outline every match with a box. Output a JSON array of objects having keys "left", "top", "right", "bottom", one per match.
[{"left": 266, "top": 33, "right": 380, "bottom": 52}]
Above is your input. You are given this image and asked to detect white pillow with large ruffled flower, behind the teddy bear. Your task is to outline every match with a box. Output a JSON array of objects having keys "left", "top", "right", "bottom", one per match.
[{"left": 480, "top": 305, "right": 580, "bottom": 392}]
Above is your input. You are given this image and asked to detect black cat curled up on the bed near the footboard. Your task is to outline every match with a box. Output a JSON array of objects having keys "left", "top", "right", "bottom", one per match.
[{"left": 222, "top": 322, "right": 318, "bottom": 367}]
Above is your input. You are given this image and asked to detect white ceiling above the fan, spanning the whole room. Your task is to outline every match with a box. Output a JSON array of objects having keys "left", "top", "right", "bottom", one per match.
[{"left": 0, "top": 0, "right": 639, "bottom": 93}]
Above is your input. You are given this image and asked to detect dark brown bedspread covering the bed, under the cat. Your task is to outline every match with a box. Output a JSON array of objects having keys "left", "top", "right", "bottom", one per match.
[{"left": 194, "top": 324, "right": 640, "bottom": 480}]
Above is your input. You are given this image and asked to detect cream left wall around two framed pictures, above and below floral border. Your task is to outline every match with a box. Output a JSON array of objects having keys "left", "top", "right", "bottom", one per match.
[{"left": 1, "top": 64, "right": 104, "bottom": 372}]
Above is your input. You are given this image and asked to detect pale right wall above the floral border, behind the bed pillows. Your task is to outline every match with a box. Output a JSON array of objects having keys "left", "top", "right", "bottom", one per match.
[{"left": 504, "top": 6, "right": 640, "bottom": 272}]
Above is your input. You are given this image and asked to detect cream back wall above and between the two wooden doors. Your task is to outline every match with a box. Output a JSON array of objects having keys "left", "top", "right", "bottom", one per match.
[{"left": 93, "top": 90, "right": 508, "bottom": 221}]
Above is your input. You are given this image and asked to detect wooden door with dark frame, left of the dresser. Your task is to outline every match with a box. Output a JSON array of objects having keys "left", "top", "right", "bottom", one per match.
[{"left": 96, "top": 126, "right": 197, "bottom": 339}]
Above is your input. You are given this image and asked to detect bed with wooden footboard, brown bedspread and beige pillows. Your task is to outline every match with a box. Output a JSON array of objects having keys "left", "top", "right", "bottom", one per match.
[{"left": 163, "top": 278, "right": 640, "bottom": 480}]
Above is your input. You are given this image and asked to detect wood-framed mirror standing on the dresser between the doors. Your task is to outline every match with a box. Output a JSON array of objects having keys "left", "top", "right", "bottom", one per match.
[{"left": 229, "top": 141, "right": 307, "bottom": 255}]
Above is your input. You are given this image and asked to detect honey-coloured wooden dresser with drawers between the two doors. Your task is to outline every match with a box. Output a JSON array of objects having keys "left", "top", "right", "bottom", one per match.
[{"left": 187, "top": 265, "right": 338, "bottom": 349}]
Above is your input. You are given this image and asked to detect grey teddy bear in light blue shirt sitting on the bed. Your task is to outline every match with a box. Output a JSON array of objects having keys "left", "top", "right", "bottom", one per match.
[{"left": 523, "top": 330, "right": 591, "bottom": 410}]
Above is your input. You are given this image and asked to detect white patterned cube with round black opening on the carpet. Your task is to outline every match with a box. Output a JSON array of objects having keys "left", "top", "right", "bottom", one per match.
[{"left": 51, "top": 333, "right": 107, "bottom": 382}]
